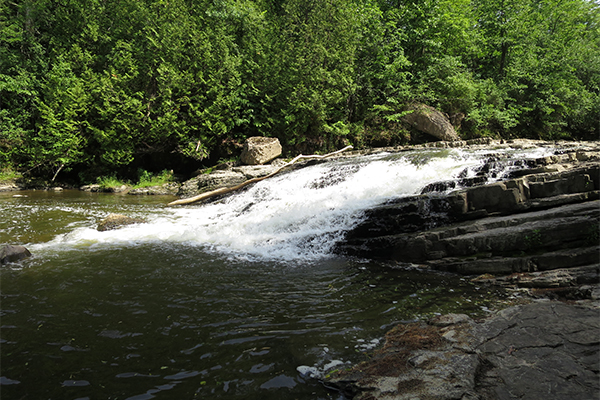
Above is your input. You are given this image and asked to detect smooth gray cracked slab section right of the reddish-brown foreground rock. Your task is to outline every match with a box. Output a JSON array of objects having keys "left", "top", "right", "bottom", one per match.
[{"left": 476, "top": 302, "right": 600, "bottom": 399}]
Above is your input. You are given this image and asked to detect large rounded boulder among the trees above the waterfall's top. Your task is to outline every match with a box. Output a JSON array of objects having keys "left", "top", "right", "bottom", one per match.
[{"left": 403, "top": 104, "right": 460, "bottom": 142}]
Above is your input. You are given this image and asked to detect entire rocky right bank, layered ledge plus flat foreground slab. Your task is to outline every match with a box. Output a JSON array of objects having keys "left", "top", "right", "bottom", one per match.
[{"left": 326, "top": 143, "right": 600, "bottom": 400}]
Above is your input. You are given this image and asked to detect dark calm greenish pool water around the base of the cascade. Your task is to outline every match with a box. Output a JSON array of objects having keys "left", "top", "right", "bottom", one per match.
[{"left": 0, "top": 186, "right": 508, "bottom": 400}]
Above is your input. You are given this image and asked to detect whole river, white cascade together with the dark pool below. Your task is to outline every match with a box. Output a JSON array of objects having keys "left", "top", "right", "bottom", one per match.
[{"left": 0, "top": 145, "right": 550, "bottom": 400}]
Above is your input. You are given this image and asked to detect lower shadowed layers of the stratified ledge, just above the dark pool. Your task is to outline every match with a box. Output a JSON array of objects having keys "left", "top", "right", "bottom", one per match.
[{"left": 338, "top": 201, "right": 600, "bottom": 275}]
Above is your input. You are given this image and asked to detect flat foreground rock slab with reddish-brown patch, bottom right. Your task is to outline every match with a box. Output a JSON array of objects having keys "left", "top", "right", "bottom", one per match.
[{"left": 326, "top": 301, "right": 600, "bottom": 400}]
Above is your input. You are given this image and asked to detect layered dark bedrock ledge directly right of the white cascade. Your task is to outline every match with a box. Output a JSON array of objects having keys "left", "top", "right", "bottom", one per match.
[{"left": 337, "top": 144, "right": 600, "bottom": 275}]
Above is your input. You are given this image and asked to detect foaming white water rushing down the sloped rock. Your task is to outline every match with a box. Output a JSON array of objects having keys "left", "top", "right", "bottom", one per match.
[{"left": 36, "top": 148, "right": 551, "bottom": 261}]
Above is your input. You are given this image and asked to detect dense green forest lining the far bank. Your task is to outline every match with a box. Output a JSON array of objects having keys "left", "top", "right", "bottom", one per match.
[{"left": 0, "top": 0, "right": 600, "bottom": 180}]
